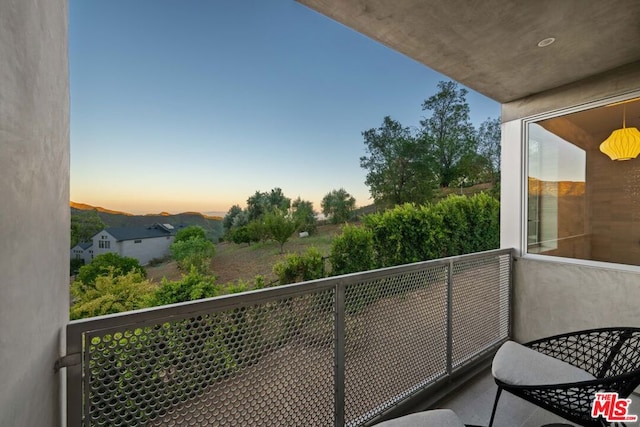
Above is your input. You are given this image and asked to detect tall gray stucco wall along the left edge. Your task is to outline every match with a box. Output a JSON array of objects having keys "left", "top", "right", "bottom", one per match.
[{"left": 0, "top": 0, "right": 70, "bottom": 427}]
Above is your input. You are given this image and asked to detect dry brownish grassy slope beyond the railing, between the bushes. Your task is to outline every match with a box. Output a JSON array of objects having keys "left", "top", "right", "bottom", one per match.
[{"left": 147, "top": 225, "right": 341, "bottom": 283}]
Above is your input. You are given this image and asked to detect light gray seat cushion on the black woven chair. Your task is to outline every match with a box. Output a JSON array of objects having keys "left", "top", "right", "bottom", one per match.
[{"left": 491, "top": 341, "right": 596, "bottom": 385}]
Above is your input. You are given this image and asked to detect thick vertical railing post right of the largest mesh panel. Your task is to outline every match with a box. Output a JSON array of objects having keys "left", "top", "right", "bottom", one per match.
[{"left": 334, "top": 282, "right": 345, "bottom": 427}]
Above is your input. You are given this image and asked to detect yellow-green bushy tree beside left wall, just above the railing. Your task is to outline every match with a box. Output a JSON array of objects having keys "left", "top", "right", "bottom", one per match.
[{"left": 70, "top": 270, "right": 154, "bottom": 320}]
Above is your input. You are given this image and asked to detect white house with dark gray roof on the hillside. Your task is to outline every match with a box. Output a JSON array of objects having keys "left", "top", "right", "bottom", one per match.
[{"left": 92, "top": 224, "right": 176, "bottom": 265}]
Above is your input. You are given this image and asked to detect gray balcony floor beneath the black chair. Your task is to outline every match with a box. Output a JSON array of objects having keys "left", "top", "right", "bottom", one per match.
[{"left": 437, "top": 369, "right": 640, "bottom": 427}]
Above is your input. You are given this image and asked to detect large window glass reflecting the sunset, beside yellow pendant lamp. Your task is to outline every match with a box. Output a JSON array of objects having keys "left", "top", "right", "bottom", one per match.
[{"left": 526, "top": 101, "right": 640, "bottom": 265}]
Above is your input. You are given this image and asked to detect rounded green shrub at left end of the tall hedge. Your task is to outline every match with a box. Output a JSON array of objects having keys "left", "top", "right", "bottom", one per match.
[{"left": 329, "top": 225, "right": 375, "bottom": 276}]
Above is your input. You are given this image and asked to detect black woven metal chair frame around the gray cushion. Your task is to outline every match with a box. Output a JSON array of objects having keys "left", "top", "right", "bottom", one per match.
[{"left": 489, "top": 328, "right": 640, "bottom": 427}]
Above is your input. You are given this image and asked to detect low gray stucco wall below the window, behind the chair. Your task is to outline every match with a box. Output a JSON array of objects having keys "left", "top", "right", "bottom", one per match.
[{"left": 513, "top": 258, "right": 640, "bottom": 341}]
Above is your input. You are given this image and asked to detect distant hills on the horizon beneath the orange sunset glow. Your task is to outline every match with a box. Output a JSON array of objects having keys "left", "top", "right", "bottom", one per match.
[{"left": 69, "top": 202, "right": 223, "bottom": 242}]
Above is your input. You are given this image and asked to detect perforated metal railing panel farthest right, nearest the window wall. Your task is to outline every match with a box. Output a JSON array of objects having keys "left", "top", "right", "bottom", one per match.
[{"left": 452, "top": 254, "right": 511, "bottom": 368}]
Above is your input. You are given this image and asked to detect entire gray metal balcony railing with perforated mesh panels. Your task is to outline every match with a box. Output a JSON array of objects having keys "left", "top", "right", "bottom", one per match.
[{"left": 66, "top": 250, "right": 512, "bottom": 427}]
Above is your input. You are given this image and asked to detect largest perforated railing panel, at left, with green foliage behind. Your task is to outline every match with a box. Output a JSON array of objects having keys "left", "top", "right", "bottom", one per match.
[{"left": 80, "top": 289, "right": 334, "bottom": 426}]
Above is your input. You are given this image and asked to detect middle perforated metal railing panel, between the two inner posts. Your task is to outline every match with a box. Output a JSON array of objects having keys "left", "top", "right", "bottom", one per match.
[{"left": 345, "top": 266, "right": 447, "bottom": 425}]
